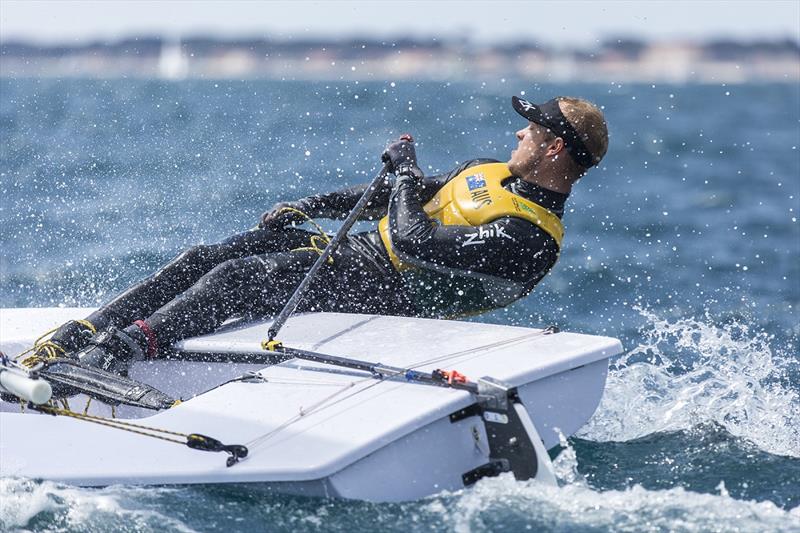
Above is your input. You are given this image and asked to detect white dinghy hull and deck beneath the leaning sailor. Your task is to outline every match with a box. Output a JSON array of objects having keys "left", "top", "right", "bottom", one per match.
[{"left": 0, "top": 309, "right": 621, "bottom": 501}]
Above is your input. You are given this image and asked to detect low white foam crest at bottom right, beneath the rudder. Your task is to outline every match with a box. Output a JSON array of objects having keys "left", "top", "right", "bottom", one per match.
[{"left": 426, "top": 474, "right": 800, "bottom": 532}]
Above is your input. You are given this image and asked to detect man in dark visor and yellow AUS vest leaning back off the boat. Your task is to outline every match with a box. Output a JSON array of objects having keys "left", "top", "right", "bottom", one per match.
[{"left": 32, "top": 96, "right": 608, "bottom": 374}]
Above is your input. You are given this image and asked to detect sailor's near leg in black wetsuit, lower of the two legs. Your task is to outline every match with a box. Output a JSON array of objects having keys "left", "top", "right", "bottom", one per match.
[{"left": 125, "top": 252, "right": 318, "bottom": 357}]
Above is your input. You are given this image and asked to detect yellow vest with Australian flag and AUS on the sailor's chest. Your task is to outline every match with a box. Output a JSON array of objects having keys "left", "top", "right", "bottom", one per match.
[{"left": 378, "top": 163, "right": 564, "bottom": 271}]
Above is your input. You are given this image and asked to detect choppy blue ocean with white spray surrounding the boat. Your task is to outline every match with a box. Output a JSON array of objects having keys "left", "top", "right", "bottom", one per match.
[{"left": 0, "top": 79, "right": 800, "bottom": 532}]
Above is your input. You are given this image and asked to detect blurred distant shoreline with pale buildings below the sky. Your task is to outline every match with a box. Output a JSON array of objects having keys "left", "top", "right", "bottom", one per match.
[{"left": 0, "top": 37, "right": 800, "bottom": 84}]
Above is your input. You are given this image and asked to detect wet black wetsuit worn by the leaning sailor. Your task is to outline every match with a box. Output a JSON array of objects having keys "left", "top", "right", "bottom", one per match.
[{"left": 89, "top": 159, "right": 567, "bottom": 351}]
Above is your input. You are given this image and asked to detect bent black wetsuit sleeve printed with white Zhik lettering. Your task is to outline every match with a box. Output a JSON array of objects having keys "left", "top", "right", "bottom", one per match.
[{"left": 389, "top": 177, "right": 558, "bottom": 283}]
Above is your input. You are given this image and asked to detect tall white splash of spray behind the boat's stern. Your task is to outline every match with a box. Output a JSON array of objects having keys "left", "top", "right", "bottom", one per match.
[{"left": 579, "top": 310, "right": 800, "bottom": 457}]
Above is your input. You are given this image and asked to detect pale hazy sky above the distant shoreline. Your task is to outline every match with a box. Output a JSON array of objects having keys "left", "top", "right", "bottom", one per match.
[{"left": 0, "top": 0, "right": 800, "bottom": 47}]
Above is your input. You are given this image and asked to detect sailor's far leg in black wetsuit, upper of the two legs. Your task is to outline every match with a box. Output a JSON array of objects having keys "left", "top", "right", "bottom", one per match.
[{"left": 82, "top": 228, "right": 311, "bottom": 329}]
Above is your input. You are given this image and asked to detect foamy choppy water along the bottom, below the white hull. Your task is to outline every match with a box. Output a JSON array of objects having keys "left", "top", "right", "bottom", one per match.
[{"left": 0, "top": 466, "right": 800, "bottom": 532}]
